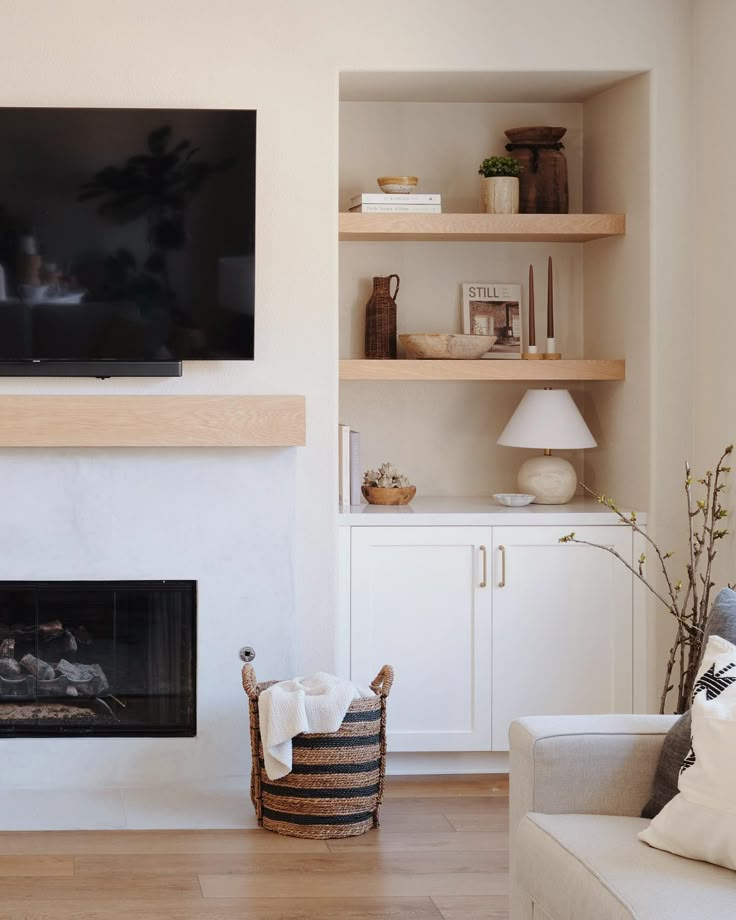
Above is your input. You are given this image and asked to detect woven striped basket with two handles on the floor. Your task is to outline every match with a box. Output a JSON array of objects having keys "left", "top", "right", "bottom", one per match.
[{"left": 243, "top": 664, "right": 394, "bottom": 840}]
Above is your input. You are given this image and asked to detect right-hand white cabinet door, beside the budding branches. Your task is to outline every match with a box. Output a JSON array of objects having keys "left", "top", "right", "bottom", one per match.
[{"left": 493, "top": 526, "right": 633, "bottom": 751}]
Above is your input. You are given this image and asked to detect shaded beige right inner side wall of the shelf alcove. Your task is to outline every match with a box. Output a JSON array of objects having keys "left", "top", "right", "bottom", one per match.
[{"left": 583, "top": 74, "right": 653, "bottom": 508}]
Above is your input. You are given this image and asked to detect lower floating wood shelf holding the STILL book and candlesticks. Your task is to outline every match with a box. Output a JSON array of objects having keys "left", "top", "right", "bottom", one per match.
[{"left": 340, "top": 358, "right": 626, "bottom": 381}]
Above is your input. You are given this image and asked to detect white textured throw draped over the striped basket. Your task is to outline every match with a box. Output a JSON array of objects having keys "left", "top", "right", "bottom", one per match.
[{"left": 258, "top": 671, "right": 375, "bottom": 779}]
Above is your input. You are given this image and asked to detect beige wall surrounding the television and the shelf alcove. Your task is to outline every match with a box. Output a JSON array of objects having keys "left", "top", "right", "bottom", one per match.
[{"left": 0, "top": 0, "right": 696, "bottom": 688}]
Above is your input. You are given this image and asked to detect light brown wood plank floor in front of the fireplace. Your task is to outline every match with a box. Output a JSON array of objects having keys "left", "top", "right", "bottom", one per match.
[{"left": 0, "top": 776, "right": 508, "bottom": 920}]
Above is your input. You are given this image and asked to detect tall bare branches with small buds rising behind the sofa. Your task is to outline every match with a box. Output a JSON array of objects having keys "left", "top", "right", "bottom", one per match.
[{"left": 560, "top": 444, "right": 733, "bottom": 713}]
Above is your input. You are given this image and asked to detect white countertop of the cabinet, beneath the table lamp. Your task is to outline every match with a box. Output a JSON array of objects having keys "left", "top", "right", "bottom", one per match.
[{"left": 338, "top": 496, "right": 646, "bottom": 527}]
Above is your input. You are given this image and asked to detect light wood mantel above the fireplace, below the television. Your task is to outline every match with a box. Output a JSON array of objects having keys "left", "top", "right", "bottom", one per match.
[{"left": 0, "top": 396, "right": 306, "bottom": 447}]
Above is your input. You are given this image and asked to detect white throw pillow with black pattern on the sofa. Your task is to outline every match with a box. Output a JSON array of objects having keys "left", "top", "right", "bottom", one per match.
[{"left": 639, "top": 636, "right": 736, "bottom": 870}]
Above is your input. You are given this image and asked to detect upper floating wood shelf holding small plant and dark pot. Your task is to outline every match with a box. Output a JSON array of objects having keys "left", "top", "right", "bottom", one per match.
[{"left": 339, "top": 213, "right": 626, "bottom": 243}]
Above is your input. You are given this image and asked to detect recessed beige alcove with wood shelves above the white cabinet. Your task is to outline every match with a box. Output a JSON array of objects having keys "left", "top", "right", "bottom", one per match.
[{"left": 339, "top": 71, "right": 650, "bottom": 507}]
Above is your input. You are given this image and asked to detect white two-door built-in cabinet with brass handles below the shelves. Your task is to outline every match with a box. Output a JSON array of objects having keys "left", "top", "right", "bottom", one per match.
[{"left": 340, "top": 500, "right": 646, "bottom": 752}]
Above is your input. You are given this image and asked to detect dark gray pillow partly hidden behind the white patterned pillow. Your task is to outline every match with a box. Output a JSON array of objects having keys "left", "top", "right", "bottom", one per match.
[{"left": 641, "top": 588, "right": 736, "bottom": 818}]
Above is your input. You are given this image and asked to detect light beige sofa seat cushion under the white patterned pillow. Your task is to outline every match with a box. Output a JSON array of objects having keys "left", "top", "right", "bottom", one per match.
[{"left": 515, "top": 812, "right": 736, "bottom": 920}]
